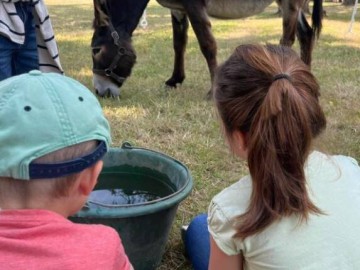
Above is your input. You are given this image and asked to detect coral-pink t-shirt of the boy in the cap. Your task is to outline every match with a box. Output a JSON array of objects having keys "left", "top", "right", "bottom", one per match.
[{"left": 0, "top": 210, "right": 131, "bottom": 270}]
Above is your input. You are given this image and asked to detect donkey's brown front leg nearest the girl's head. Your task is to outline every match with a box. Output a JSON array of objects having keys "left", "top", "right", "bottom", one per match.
[{"left": 183, "top": 0, "right": 217, "bottom": 98}]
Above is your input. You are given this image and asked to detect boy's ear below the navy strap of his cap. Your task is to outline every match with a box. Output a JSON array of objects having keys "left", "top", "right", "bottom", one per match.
[{"left": 79, "top": 160, "right": 103, "bottom": 196}]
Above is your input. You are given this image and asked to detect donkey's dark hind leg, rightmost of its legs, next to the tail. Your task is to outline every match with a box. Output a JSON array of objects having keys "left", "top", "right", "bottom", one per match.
[{"left": 296, "top": 12, "right": 315, "bottom": 66}]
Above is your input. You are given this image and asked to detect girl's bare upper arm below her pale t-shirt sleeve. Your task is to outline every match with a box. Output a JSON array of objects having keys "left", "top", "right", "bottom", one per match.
[{"left": 209, "top": 236, "right": 243, "bottom": 270}]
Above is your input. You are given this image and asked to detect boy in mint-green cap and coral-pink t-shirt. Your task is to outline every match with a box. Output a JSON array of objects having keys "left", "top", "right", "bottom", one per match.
[{"left": 0, "top": 71, "right": 132, "bottom": 270}]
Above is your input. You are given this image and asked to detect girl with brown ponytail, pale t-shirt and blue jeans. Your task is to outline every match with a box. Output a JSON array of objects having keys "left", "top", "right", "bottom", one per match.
[{"left": 185, "top": 45, "right": 360, "bottom": 270}]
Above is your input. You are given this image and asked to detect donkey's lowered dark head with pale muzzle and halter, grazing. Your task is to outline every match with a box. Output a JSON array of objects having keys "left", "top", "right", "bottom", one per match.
[{"left": 91, "top": 0, "right": 136, "bottom": 97}]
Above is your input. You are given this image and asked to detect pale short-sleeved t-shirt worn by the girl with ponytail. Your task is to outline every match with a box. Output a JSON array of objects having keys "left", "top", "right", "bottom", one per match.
[{"left": 208, "top": 151, "right": 360, "bottom": 270}]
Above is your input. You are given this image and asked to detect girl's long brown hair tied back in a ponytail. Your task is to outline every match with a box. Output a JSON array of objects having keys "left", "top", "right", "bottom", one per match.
[{"left": 214, "top": 45, "right": 326, "bottom": 238}]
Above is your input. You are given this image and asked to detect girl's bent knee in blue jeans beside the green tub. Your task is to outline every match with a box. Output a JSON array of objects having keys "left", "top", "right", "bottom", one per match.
[{"left": 184, "top": 214, "right": 210, "bottom": 270}]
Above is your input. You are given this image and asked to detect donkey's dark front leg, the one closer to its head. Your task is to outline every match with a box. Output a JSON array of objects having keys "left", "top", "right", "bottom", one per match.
[{"left": 165, "top": 10, "right": 189, "bottom": 88}]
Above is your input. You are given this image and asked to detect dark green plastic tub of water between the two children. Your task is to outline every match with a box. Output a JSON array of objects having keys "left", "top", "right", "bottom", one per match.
[{"left": 70, "top": 143, "right": 193, "bottom": 270}]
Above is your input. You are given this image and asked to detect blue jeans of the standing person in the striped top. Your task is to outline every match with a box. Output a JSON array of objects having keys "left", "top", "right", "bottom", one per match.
[{"left": 0, "top": 2, "right": 39, "bottom": 81}]
